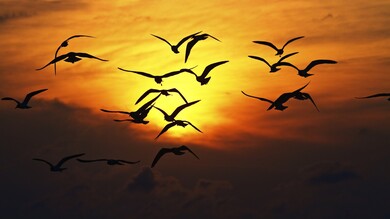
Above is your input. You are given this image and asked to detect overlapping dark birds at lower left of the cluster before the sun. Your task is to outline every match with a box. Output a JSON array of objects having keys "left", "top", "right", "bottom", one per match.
[{"left": 100, "top": 94, "right": 161, "bottom": 125}]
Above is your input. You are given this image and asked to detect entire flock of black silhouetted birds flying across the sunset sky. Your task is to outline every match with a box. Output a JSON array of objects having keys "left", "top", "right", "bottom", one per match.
[{"left": 2, "top": 31, "right": 390, "bottom": 172}]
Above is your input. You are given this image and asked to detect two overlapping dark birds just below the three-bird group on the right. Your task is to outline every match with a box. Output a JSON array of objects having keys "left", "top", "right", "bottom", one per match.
[{"left": 241, "top": 82, "right": 319, "bottom": 111}]
